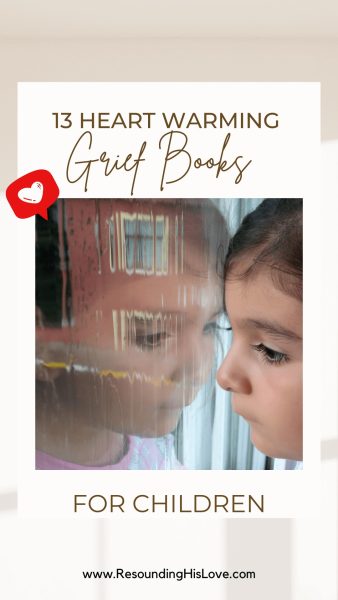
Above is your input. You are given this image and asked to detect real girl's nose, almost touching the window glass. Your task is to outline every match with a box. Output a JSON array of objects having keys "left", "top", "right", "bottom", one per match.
[{"left": 216, "top": 348, "right": 252, "bottom": 394}]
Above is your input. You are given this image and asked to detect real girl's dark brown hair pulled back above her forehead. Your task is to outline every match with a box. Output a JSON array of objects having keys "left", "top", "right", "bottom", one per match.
[{"left": 226, "top": 198, "right": 303, "bottom": 300}]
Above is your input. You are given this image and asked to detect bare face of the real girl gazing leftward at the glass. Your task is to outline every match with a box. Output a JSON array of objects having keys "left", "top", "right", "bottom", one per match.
[{"left": 217, "top": 265, "right": 303, "bottom": 460}]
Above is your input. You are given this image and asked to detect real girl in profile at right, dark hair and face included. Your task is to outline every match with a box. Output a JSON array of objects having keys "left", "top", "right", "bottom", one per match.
[{"left": 217, "top": 199, "right": 303, "bottom": 460}]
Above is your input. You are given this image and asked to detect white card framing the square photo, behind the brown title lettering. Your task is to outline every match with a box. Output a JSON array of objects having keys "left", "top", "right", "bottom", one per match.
[{"left": 18, "top": 83, "right": 322, "bottom": 518}]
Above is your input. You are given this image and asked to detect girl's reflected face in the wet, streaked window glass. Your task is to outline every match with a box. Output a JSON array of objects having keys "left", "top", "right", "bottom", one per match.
[{"left": 37, "top": 275, "right": 222, "bottom": 436}]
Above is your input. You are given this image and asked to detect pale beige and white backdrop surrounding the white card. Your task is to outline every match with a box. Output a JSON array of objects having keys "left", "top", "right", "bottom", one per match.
[{"left": 0, "top": 0, "right": 338, "bottom": 600}]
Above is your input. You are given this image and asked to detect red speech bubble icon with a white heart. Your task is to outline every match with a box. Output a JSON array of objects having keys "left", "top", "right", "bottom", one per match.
[{"left": 6, "top": 169, "right": 60, "bottom": 220}]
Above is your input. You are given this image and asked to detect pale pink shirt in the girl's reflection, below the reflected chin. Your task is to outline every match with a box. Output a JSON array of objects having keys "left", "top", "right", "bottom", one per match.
[{"left": 35, "top": 434, "right": 184, "bottom": 471}]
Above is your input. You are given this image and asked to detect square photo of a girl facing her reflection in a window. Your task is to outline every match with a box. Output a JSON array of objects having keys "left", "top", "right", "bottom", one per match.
[{"left": 36, "top": 199, "right": 302, "bottom": 469}]
